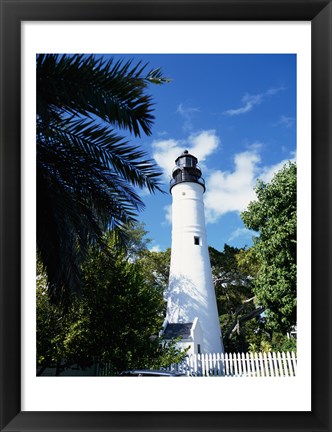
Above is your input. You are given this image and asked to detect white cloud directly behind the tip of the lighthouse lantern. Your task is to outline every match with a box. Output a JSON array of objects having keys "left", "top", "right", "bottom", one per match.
[{"left": 152, "top": 130, "right": 219, "bottom": 180}]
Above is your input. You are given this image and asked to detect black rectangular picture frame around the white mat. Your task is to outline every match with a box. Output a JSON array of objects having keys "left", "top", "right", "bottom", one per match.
[{"left": 0, "top": 0, "right": 332, "bottom": 432}]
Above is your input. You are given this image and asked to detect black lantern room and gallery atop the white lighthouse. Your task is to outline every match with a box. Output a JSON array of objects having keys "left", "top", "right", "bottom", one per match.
[{"left": 170, "top": 150, "right": 205, "bottom": 191}]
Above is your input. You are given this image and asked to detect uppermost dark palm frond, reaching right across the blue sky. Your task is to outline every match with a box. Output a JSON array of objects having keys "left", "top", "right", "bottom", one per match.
[{"left": 37, "top": 55, "right": 168, "bottom": 136}]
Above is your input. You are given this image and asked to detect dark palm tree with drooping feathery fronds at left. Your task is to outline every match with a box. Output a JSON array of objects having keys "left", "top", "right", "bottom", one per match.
[{"left": 36, "top": 54, "right": 168, "bottom": 304}]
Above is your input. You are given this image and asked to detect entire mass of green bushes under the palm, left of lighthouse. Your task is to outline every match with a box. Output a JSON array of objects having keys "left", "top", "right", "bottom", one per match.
[{"left": 37, "top": 235, "right": 187, "bottom": 374}]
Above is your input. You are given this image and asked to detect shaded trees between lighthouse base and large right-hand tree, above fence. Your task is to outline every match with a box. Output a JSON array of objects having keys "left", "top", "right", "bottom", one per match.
[{"left": 209, "top": 244, "right": 296, "bottom": 352}]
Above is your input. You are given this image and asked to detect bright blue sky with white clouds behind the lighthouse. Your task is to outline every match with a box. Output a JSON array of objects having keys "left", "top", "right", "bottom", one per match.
[{"left": 110, "top": 54, "right": 296, "bottom": 250}]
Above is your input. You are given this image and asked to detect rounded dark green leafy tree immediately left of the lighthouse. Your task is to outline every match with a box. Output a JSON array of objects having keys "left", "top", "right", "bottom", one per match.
[{"left": 79, "top": 233, "right": 167, "bottom": 370}]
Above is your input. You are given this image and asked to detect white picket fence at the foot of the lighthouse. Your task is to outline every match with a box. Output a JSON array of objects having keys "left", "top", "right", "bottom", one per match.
[{"left": 167, "top": 352, "right": 297, "bottom": 377}]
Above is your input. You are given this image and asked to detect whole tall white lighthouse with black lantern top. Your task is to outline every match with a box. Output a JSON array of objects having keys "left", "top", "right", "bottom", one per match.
[{"left": 163, "top": 150, "right": 224, "bottom": 354}]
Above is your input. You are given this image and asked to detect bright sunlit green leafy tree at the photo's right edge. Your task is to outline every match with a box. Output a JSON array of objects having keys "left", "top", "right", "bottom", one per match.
[{"left": 242, "top": 163, "right": 297, "bottom": 334}]
